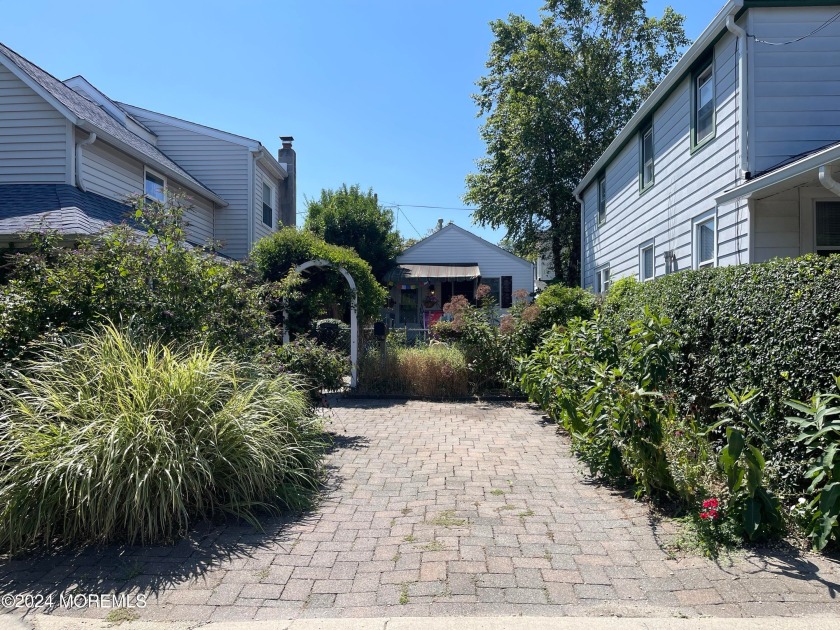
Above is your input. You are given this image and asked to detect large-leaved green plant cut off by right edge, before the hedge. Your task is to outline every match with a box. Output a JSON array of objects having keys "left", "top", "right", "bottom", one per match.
[{"left": 786, "top": 376, "right": 840, "bottom": 549}]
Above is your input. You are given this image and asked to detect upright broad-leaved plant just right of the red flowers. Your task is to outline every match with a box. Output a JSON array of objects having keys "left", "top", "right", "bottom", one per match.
[{"left": 710, "top": 389, "right": 782, "bottom": 540}]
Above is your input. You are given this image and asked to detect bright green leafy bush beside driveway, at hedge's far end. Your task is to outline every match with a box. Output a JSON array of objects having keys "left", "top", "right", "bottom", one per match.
[{"left": 520, "top": 312, "right": 676, "bottom": 495}]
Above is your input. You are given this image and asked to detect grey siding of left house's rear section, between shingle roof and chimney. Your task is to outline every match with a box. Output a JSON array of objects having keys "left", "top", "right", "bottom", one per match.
[{"left": 124, "top": 109, "right": 253, "bottom": 258}]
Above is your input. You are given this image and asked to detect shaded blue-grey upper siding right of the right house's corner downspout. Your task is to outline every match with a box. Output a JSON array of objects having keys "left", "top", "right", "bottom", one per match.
[{"left": 748, "top": 5, "right": 840, "bottom": 172}]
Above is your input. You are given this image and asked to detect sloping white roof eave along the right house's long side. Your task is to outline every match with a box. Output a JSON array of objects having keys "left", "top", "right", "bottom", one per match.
[{"left": 574, "top": 0, "right": 744, "bottom": 196}]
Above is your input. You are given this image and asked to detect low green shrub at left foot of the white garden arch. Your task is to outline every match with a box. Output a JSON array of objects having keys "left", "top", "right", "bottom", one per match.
[{"left": 261, "top": 335, "right": 350, "bottom": 399}]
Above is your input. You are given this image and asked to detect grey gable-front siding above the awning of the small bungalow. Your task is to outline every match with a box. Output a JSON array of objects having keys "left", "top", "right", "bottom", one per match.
[{"left": 397, "top": 227, "right": 534, "bottom": 312}]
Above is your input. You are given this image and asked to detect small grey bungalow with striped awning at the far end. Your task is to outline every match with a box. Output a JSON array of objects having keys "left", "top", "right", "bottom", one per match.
[{"left": 386, "top": 222, "right": 534, "bottom": 329}]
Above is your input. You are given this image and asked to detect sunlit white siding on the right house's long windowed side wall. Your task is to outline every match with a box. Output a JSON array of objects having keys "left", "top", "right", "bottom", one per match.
[{"left": 582, "top": 26, "right": 749, "bottom": 288}]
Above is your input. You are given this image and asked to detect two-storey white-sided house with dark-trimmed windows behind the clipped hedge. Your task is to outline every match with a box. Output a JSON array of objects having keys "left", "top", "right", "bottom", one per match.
[{"left": 575, "top": 0, "right": 840, "bottom": 292}]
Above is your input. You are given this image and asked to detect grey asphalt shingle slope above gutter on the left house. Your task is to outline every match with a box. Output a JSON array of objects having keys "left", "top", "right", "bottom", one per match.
[{"left": 0, "top": 43, "right": 219, "bottom": 204}]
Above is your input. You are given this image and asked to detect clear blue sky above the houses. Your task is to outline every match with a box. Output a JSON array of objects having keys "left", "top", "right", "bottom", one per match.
[{"left": 0, "top": 0, "right": 723, "bottom": 242}]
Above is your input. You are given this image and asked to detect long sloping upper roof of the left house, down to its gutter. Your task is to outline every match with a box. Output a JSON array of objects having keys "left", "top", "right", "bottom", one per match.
[{"left": 0, "top": 44, "right": 227, "bottom": 206}]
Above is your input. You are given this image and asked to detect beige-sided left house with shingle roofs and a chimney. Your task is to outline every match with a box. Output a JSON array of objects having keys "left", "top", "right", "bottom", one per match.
[{"left": 0, "top": 44, "right": 296, "bottom": 258}]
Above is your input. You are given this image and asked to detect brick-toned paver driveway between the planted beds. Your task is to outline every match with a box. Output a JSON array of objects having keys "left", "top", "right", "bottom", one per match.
[{"left": 0, "top": 400, "right": 840, "bottom": 621}]
